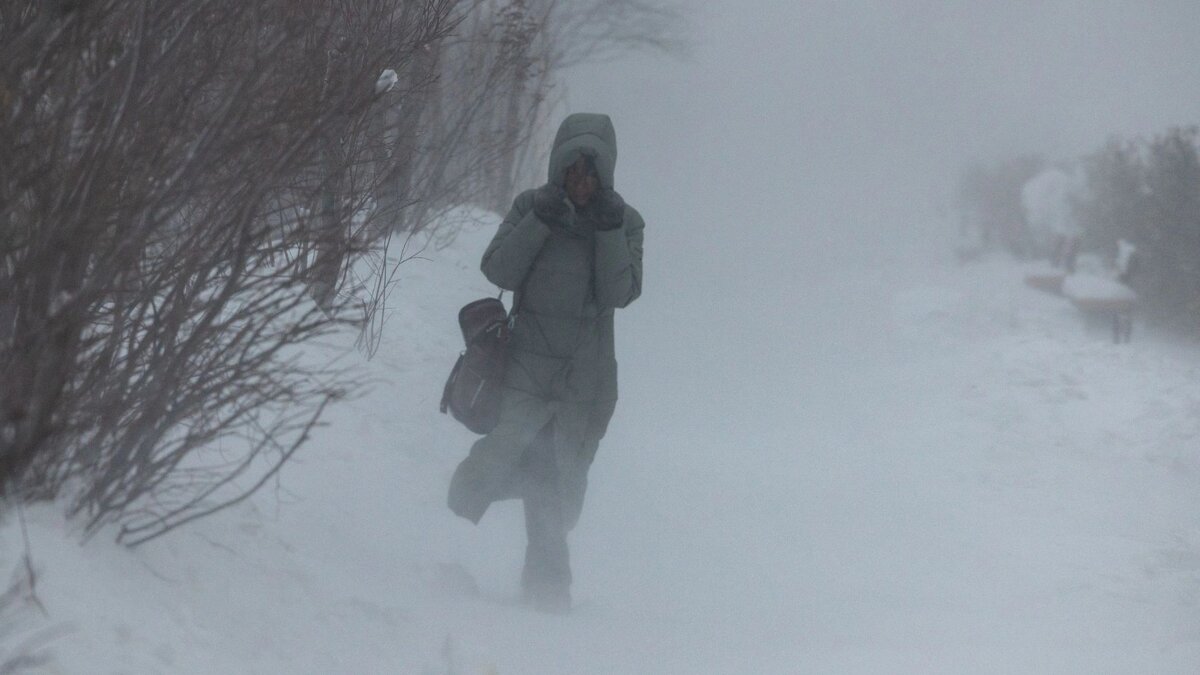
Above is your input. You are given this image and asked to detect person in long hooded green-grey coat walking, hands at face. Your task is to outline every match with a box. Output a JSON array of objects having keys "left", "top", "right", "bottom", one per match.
[{"left": 448, "top": 113, "right": 646, "bottom": 611}]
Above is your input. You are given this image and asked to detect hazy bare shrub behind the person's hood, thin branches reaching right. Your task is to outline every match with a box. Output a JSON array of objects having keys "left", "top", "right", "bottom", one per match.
[{"left": 362, "top": 0, "right": 686, "bottom": 345}]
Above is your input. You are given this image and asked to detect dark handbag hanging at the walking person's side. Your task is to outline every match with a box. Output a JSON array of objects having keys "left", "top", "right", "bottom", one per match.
[{"left": 440, "top": 298, "right": 515, "bottom": 434}]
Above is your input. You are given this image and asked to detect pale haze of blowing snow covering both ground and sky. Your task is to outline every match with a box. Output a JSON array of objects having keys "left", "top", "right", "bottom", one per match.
[{"left": 9, "top": 0, "right": 1200, "bottom": 674}]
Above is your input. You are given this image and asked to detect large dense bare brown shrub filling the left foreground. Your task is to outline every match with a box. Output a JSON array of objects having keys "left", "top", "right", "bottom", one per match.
[{"left": 0, "top": 0, "right": 456, "bottom": 543}]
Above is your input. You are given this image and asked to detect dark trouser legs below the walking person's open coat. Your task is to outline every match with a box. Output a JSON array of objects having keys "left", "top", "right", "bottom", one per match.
[{"left": 520, "top": 422, "right": 574, "bottom": 595}]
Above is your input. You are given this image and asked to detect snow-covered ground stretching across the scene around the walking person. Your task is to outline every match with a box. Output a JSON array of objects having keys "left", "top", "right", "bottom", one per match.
[{"left": 0, "top": 208, "right": 1200, "bottom": 674}]
